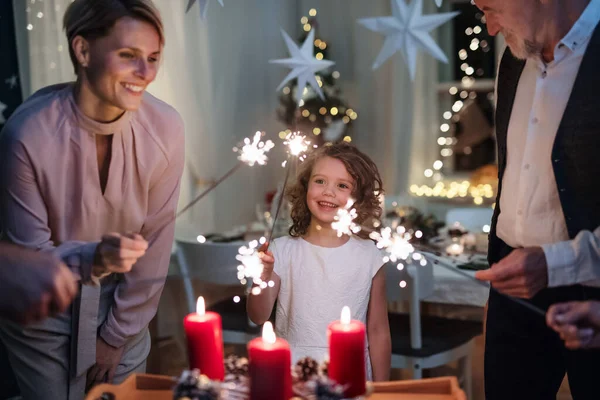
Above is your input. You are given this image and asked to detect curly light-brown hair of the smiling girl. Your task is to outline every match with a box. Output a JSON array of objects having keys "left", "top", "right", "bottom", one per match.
[{"left": 286, "top": 142, "right": 383, "bottom": 239}]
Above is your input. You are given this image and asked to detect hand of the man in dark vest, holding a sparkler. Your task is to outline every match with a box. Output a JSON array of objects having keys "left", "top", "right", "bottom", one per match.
[{"left": 475, "top": 247, "right": 548, "bottom": 299}]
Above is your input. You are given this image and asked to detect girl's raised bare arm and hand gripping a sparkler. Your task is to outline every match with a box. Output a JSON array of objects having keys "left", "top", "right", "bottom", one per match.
[{"left": 246, "top": 251, "right": 281, "bottom": 325}]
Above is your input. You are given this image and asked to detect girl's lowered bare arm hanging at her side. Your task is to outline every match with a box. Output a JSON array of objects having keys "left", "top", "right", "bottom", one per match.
[{"left": 367, "top": 268, "right": 392, "bottom": 382}]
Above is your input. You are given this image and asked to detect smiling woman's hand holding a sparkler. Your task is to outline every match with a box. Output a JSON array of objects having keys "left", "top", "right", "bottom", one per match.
[{"left": 92, "top": 233, "right": 148, "bottom": 276}]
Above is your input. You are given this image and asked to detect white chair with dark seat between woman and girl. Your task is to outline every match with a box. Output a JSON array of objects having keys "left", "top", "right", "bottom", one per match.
[{"left": 176, "top": 239, "right": 260, "bottom": 344}]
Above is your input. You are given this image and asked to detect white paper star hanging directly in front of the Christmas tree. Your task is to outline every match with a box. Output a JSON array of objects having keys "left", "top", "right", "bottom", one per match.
[{"left": 269, "top": 29, "right": 335, "bottom": 103}]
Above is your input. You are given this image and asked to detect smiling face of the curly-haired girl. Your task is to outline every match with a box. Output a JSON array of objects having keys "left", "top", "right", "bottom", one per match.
[{"left": 306, "top": 156, "right": 355, "bottom": 226}]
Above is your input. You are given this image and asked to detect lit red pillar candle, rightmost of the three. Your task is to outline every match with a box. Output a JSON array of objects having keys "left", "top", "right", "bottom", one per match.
[{"left": 327, "top": 307, "right": 367, "bottom": 397}]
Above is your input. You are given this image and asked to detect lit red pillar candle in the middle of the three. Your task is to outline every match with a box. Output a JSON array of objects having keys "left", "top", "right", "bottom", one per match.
[{"left": 248, "top": 322, "right": 292, "bottom": 400}]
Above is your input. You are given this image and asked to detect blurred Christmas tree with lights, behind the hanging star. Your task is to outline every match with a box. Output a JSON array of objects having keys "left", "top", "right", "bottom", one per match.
[{"left": 277, "top": 8, "right": 358, "bottom": 145}]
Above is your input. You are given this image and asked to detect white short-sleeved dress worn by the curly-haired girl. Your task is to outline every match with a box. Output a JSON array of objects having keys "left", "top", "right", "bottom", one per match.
[{"left": 271, "top": 236, "right": 383, "bottom": 379}]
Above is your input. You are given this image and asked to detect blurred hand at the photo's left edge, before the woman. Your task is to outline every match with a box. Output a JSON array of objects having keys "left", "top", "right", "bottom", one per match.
[{"left": 0, "top": 244, "right": 78, "bottom": 324}]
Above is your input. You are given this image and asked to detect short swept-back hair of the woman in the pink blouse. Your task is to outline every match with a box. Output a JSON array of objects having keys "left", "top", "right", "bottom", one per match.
[{"left": 63, "top": 0, "right": 165, "bottom": 74}]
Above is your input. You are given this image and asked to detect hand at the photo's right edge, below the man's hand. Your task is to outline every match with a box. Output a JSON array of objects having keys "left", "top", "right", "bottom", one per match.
[{"left": 546, "top": 301, "right": 600, "bottom": 349}]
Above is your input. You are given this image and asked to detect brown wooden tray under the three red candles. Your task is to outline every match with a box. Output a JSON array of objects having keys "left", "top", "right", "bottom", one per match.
[{"left": 86, "top": 374, "right": 467, "bottom": 400}]
